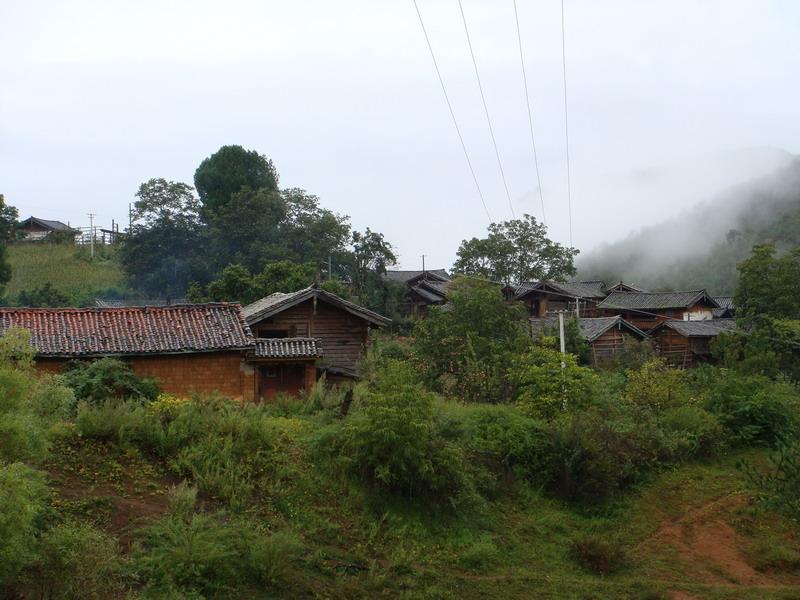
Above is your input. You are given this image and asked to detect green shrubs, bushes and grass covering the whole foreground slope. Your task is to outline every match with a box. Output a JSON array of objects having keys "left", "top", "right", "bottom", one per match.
[{"left": 0, "top": 250, "right": 800, "bottom": 598}]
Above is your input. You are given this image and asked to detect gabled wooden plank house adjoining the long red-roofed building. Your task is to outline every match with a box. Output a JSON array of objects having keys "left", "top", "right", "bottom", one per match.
[{"left": 243, "top": 286, "right": 391, "bottom": 384}]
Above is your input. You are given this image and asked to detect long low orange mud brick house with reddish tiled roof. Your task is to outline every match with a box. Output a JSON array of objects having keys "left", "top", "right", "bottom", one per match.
[{"left": 0, "top": 303, "right": 255, "bottom": 400}]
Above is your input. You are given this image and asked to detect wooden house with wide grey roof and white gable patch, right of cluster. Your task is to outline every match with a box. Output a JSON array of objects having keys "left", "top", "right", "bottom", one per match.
[{"left": 597, "top": 290, "right": 720, "bottom": 331}]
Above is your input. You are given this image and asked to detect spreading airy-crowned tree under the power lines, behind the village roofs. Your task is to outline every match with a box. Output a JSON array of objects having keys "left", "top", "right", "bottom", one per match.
[{"left": 453, "top": 215, "right": 578, "bottom": 283}]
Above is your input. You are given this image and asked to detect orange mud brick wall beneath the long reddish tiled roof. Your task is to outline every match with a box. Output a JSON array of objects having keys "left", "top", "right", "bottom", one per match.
[{"left": 36, "top": 352, "right": 255, "bottom": 400}]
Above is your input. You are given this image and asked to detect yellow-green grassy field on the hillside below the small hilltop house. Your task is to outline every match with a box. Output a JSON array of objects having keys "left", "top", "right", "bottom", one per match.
[{"left": 5, "top": 244, "right": 122, "bottom": 300}]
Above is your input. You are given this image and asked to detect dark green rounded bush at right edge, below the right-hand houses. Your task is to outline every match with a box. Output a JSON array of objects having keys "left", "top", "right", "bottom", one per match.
[{"left": 707, "top": 369, "right": 800, "bottom": 446}]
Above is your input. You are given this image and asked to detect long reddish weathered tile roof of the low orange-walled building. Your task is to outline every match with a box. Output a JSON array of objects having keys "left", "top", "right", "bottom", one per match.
[{"left": 0, "top": 303, "right": 253, "bottom": 357}]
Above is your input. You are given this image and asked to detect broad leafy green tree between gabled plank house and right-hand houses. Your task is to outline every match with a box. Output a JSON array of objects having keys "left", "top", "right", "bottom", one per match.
[{"left": 413, "top": 277, "right": 532, "bottom": 402}]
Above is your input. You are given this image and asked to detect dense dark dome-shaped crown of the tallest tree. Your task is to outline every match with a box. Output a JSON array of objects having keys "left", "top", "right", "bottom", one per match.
[{"left": 194, "top": 146, "right": 278, "bottom": 217}]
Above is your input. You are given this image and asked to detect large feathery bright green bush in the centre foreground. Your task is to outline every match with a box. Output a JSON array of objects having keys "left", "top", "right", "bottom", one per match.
[{"left": 319, "top": 362, "right": 471, "bottom": 506}]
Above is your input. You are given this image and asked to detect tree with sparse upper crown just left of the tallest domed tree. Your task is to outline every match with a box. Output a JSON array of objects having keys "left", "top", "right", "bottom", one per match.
[{"left": 119, "top": 179, "right": 206, "bottom": 298}]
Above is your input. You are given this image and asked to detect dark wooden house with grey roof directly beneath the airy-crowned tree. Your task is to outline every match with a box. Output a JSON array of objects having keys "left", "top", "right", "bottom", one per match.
[{"left": 510, "top": 281, "right": 607, "bottom": 318}]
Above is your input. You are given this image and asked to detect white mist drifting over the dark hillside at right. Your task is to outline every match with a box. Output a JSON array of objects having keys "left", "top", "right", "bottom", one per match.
[{"left": 577, "top": 157, "right": 800, "bottom": 294}]
